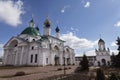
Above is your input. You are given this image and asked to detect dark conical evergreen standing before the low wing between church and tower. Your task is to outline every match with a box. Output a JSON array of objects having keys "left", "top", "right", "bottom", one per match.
[{"left": 80, "top": 54, "right": 89, "bottom": 71}]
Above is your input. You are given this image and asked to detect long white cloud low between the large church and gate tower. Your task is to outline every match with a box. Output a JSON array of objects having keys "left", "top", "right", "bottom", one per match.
[{"left": 60, "top": 32, "right": 97, "bottom": 49}]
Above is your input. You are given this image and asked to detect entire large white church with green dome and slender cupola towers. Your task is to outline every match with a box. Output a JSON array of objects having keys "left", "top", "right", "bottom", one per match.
[{"left": 3, "top": 18, "right": 75, "bottom": 66}]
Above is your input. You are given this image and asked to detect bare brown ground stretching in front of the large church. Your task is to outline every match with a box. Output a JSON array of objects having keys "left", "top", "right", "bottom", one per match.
[{"left": 0, "top": 66, "right": 76, "bottom": 80}]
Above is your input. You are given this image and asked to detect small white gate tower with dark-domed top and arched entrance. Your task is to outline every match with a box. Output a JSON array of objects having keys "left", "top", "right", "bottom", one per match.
[{"left": 95, "top": 38, "right": 111, "bottom": 66}]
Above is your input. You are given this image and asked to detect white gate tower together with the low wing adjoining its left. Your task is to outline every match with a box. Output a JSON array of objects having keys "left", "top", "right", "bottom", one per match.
[{"left": 75, "top": 38, "right": 111, "bottom": 66}]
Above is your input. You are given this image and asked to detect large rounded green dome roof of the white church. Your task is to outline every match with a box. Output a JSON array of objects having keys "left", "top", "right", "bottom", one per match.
[{"left": 21, "top": 27, "right": 40, "bottom": 36}]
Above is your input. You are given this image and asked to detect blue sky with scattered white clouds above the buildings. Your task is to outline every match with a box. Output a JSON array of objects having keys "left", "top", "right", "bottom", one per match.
[{"left": 0, "top": 0, "right": 120, "bottom": 56}]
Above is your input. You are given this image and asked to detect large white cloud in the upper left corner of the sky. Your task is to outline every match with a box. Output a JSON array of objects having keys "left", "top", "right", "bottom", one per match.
[{"left": 0, "top": 0, "right": 24, "bottom": 26}]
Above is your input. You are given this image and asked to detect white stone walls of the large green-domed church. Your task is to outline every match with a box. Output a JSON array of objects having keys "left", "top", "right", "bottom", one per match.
[{"left": 3, "top": 35, "right": 75, "bottom": 66}]
